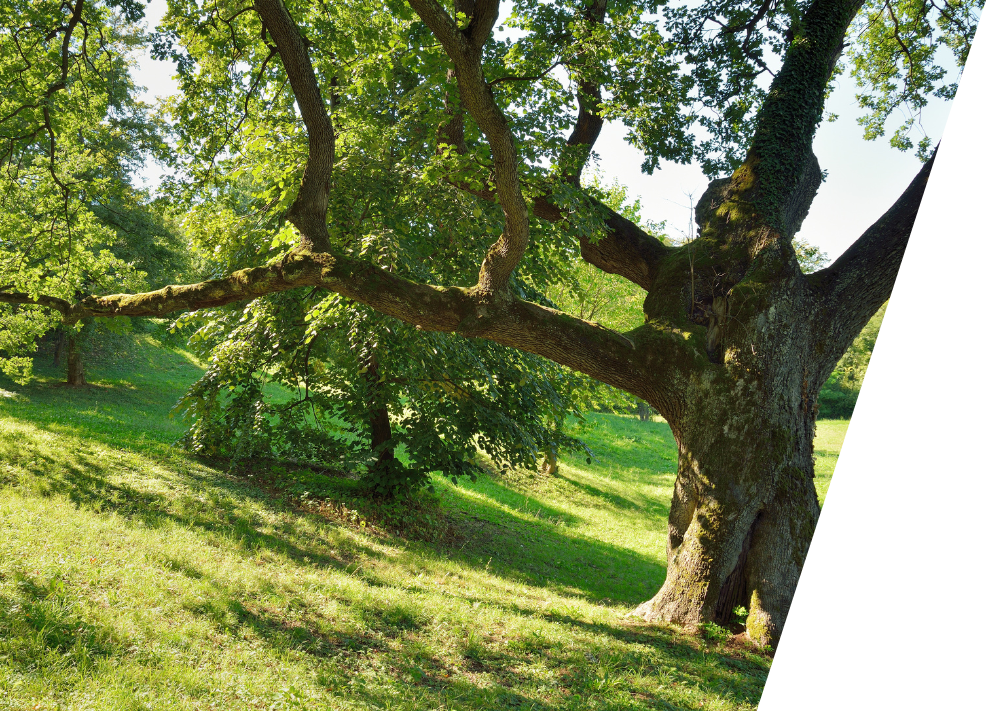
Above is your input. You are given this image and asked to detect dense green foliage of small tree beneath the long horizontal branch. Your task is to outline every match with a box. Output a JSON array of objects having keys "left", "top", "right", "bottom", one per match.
[{"left": 172, "top": 293, "right": 585, "bottom": 496}]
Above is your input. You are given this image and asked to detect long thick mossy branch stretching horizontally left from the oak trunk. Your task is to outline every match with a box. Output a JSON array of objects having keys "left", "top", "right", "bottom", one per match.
[{"left": 19, "top": 252, "right": 696, "bottom": 402}]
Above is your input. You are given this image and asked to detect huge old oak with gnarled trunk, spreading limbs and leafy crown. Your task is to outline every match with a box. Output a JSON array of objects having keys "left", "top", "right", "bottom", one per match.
[{"left": 0, "top": 0, "right": 981, "bottom": 646}]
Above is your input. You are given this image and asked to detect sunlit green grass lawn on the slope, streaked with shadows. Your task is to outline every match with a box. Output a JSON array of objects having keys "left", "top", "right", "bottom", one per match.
[{"left": 0, "top": 341, "right": 835, "bottom": 710}]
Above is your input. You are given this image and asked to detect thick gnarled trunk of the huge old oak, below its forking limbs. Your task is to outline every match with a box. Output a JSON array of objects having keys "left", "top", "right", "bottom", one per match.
[{"left": 636, "top": 274, "right": 826, "bottom": 645}]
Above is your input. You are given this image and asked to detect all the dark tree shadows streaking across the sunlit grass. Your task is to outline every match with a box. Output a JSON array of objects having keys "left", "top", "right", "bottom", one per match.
[{"left": 0, "top": 372, "right": 767, "bottom": 711}]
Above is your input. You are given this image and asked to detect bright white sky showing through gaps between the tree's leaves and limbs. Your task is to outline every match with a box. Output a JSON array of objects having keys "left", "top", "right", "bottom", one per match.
[{"left": 135, "top": 0, "right": 951, "bottom": 259}]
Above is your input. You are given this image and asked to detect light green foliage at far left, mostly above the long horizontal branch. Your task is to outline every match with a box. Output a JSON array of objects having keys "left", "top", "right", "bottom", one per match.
[{"left": 0, "top": 0, "right": 194, "bottom": 380}]
